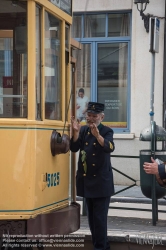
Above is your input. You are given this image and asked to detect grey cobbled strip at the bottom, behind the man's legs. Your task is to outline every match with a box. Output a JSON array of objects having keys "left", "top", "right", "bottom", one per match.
[{"left": 75, "top": 216, "right": 166, "bottom": 246}]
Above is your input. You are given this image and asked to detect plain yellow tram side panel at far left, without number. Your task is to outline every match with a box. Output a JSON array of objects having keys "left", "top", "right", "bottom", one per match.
[{"left": 0, "top": 127, "right": 35, "bottom": 216}]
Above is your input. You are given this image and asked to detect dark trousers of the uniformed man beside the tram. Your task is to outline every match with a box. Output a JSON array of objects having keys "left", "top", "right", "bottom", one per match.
[{"left": 85, "top": 197, "right": 110, "bottom": 250}]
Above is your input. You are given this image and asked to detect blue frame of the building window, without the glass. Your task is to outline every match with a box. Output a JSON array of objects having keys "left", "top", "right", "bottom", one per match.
[{"left": 73, "top": 11, "right": 131, "bottom": 133}]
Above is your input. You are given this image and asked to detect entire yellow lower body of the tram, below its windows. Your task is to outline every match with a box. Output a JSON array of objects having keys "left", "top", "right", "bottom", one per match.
[{"left": 0, "top": 126, "right": 69, "bottom": 219}]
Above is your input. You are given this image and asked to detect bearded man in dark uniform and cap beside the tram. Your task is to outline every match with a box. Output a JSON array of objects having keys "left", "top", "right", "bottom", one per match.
[{"left": 70, "top": 102, "right": 115, "bottom": 250}]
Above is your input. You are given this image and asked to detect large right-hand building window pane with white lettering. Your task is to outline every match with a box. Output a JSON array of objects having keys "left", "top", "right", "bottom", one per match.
[{"left": 97, "top": 43, "right": 128, "bottom": 128}]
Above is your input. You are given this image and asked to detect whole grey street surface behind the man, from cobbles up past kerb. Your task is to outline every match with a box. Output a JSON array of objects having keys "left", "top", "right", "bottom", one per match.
[{"left": 75, "top": 186, "right": 166, "bottom": 249}]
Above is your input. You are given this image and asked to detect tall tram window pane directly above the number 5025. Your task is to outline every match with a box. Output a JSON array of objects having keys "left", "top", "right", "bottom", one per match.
[{"left": 45, "top": 12, "right": 61, "bottom": 120}]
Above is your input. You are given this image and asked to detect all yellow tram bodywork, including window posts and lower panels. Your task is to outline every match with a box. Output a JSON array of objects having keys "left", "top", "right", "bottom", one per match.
[{"left": 0, "top": 0, "right": 72, "bottom": 220}]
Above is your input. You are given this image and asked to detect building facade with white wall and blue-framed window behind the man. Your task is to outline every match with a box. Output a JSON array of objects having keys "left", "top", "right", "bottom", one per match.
[{"left": 71, "top": 0, "right": 165, "bottom": 185}]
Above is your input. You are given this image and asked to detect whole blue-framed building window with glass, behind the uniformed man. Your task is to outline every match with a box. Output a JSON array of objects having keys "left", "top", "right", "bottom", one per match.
[{"left": 72, "top": 13, "right": 130, "bottom": 132}]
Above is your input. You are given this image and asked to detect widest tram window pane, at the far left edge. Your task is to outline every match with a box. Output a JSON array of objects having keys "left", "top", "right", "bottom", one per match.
[{"left": 0, "top": 0, "right": 27, "bottom": 118}]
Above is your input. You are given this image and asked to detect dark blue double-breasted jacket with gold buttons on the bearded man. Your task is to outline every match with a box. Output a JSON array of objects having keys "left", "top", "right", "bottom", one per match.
[{"left": 70, "top": 124, "right": 115, "bottom": 198}]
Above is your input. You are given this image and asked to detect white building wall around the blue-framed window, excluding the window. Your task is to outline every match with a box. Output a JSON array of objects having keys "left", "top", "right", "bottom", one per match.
[{"left": 73, "top": 0, "right": 165, "bottom": 185}]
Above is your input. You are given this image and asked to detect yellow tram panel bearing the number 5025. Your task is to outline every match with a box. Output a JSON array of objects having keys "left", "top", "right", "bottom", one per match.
[{"left": 34, "top": 130, "right": 69, "bottom": 211}]
